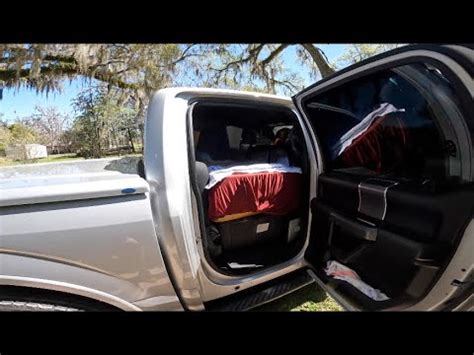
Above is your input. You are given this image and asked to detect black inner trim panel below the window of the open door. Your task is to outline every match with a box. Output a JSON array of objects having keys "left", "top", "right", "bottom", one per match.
[{"left": 307, "top": 174, "right": 474, "bottom": 298}]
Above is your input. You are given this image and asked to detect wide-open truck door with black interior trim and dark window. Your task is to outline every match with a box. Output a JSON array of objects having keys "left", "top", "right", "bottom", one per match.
[{"left": 294, "top": 46, "right": 474, "bottom": 310}]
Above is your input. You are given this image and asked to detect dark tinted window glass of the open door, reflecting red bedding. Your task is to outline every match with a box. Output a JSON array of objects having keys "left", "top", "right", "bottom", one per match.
[{"left": 304, "top": 63, "right": 459, "bottom": 184}]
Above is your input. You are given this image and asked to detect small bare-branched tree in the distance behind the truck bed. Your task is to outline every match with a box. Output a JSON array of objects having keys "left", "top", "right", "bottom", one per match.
[{"left": 27, "top": 106, "right": 70, "bottom": 153}]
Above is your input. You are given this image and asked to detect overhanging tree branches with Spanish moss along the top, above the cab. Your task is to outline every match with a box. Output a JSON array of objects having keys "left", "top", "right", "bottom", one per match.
[{"left": 0, "top": 43, "right": 334, "bottom": 101}]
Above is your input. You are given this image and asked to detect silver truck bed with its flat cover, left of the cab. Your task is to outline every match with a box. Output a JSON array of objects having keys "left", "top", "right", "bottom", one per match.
[{"left": 0, "top": 160, "right": 182, "bottom": 310}]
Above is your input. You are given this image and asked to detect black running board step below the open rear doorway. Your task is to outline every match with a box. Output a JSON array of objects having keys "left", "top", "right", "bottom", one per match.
[{"left": 206, "top": 270, "right": 314, "bottom": 312}]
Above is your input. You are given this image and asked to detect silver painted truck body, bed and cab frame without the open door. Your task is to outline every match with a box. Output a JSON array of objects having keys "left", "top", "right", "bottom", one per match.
[{"left": 0, "top": 88, "right": 316, "bottom": 310}]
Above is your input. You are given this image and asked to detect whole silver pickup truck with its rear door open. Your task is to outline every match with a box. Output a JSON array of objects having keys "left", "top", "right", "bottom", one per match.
[{"left": 0, "top": 45, "right": 474, "bottom": 311}]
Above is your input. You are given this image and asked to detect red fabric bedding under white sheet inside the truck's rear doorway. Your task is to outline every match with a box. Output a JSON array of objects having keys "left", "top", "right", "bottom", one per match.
[{"left": 209, "top": 172, "right": 302, "bottom": 221}]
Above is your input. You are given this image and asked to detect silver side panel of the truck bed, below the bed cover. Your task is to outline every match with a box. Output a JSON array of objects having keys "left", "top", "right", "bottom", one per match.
[{"left": 0, "top": 193, "right": 182, "bottom": 310}]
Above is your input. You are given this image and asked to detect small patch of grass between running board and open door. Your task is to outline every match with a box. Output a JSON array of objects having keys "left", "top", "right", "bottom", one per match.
[{"left": 254, "top": 283, "right": 342, "bottom": 312}]
